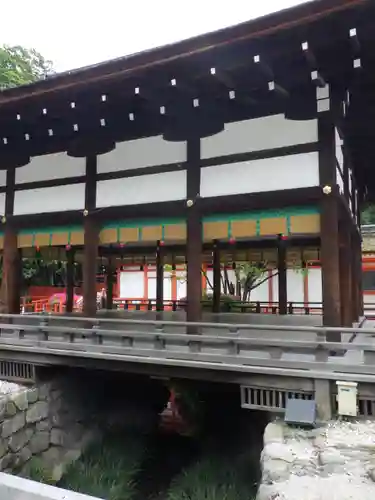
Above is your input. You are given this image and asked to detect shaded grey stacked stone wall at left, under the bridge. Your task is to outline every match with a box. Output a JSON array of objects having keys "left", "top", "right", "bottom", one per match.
[{"left": 0, "top": 381, "right": 93, "bottom": 481}]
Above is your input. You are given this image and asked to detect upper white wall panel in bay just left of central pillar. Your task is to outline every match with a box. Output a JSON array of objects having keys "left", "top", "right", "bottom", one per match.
[{"left": 98, "top": 136, "right": 186, "bottom": 173}]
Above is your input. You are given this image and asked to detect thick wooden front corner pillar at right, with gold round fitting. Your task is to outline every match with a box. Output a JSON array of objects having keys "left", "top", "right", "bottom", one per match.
[{"left": 318, "top": 86, "right": 341, "bottom": 342}]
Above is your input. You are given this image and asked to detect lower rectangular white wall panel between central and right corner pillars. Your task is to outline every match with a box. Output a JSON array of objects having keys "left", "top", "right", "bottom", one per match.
[{"left": 201, "top": 153, "right": 319, "bottom": 198}]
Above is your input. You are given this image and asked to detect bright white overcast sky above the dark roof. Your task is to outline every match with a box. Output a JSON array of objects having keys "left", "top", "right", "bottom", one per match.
[{"left": 0, "top": 0, "right": 303, "bottom": 71}]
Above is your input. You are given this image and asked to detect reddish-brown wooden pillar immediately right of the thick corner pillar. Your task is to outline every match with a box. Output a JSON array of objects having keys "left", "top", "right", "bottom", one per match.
[{"left": 339, "top": 221, "right": 353, "bottom": 327}]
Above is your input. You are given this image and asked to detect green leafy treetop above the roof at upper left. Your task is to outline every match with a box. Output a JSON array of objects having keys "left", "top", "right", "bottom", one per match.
[{"left": 0, "top": 45, "right": 52, "bottom": 90}]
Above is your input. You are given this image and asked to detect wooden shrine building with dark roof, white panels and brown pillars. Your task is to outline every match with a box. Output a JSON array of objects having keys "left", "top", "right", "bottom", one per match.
[{"left": 0, "top": 0, "right": 375, "bottom": 325}]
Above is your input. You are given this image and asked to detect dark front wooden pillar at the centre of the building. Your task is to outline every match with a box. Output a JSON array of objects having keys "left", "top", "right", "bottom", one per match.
[{"left": 186, "top": 137, "right": 202, "bottom": 324}]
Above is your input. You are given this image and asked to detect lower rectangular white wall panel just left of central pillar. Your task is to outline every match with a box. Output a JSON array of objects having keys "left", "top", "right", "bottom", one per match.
[{"left": 96, "top": 170, "right": 186, "bottom": 207}]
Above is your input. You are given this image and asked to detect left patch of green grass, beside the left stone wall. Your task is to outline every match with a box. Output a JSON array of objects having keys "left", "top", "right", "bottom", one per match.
[{"left": 59, "top": 432, "right": 146, "bottom": 500}]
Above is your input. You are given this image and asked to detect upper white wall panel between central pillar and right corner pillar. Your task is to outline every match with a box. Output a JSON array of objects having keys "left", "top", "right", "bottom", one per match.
[{"left": 201, "top": 115, "right": 318, "bottom": 158}]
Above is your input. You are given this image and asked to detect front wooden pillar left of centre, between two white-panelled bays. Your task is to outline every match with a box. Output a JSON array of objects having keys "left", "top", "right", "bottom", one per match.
[{"left": 82, "top": 155, "right": 99, "bottom": 317}]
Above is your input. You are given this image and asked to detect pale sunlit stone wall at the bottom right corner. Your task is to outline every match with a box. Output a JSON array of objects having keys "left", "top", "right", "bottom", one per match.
[{"left": 257, "top": 421, "right": 375, "bottom": 500}]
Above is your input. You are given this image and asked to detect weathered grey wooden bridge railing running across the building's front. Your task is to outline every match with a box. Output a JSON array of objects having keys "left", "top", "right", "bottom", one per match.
[{"left": 0, "top": 315, "right": 375, "bottom": 382}]
